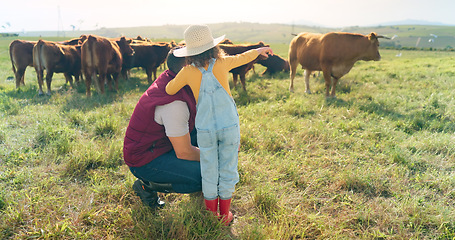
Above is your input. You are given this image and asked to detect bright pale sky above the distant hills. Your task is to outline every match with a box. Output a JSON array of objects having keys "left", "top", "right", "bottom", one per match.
[{"left": 0, "top": 0, "right": 455, "bottom": 32}]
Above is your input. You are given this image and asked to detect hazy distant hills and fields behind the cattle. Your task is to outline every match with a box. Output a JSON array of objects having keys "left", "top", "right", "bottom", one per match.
[{"left": 8, "top": 20, "right": 455, "bottom": 49}]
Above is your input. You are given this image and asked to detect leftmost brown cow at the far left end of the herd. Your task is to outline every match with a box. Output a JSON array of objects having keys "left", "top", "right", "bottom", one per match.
[{"left": 9, "top": 40, "right": 36, "bottom": 88}]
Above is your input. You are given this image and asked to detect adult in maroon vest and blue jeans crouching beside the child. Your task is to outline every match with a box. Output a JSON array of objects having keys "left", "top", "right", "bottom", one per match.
[{"left": 123, "top": 47, "right": 202, "bottom": 208}]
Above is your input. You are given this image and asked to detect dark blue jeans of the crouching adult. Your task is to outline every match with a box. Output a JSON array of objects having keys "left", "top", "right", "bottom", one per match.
[{"left": 130, "top": 131, "right": 202, "bottom": 193}]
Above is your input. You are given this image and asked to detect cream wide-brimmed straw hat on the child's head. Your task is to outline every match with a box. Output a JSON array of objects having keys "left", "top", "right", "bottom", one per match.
[{"left": 174, "top": 25, "right": 226, "bottom": 57}]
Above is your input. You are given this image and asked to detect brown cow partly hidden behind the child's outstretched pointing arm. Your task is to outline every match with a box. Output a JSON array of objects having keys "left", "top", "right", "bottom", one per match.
[{"left": 218, "top": 41, "right": 269, "bottom": 91}]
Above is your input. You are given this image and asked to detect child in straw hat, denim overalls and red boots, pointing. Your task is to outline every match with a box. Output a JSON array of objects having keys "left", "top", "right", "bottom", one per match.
[{"left": 166, "top": 25, "right": 273, "bottom": 225}]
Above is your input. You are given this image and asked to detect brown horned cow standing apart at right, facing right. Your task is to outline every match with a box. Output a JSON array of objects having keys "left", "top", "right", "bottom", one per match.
[{"left": 289, "top": 32, "right": 384, "bottom": 97}]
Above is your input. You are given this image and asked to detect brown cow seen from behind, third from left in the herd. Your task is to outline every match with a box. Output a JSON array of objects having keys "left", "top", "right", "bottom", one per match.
[{"left": 81, "top": 35, "right": 134, "bottom": 97}]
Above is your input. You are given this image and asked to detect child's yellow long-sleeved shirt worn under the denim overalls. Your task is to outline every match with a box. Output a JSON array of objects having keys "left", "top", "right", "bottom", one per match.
[{"left": 166, "top": 49, "right": 259, "bottom": 102}]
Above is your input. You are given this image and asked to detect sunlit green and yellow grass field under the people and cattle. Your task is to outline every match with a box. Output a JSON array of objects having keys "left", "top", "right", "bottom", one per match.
[{"left": 0, "top": 36, "right": 455, "bottom": 239}]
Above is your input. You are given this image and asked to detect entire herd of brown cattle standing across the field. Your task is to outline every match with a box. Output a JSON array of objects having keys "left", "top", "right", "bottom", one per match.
[{"left": 9, "top": 33, "right": 383, "bottom": 97}]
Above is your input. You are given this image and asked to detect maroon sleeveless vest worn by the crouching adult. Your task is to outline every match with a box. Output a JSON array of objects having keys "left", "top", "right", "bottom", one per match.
[{"left": 123, "top": 70, "right": 196, "bottom": 167}]
